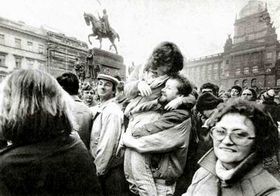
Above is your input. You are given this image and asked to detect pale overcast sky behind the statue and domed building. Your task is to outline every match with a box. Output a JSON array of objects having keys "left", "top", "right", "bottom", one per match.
[{"left": 0, "top": 0, "right": 280, "bottom": 65}]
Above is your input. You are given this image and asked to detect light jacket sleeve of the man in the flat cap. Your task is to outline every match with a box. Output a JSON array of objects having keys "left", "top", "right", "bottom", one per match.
[{"left": 94, "top": 108, "right": 123, "bottom": 175}]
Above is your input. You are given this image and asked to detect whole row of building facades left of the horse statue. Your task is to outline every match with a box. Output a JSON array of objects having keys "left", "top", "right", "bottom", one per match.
[{"left": 0, "top": 14, "right": 88, "bottom": 81}]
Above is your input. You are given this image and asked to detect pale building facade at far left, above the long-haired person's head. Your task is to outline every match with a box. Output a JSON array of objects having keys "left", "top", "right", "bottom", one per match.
[{"left": 0, "top": 18, "right": 47, "bottom": 80}]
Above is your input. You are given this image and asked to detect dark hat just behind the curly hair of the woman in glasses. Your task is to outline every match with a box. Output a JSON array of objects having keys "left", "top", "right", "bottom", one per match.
[{"left": 196, "top": 92, "right": 223, "bottom": 112}]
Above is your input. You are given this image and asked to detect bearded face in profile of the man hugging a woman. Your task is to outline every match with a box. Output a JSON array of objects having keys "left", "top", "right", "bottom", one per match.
[{"left": 159, "top": 79, "right": 179, "bottom": 103}]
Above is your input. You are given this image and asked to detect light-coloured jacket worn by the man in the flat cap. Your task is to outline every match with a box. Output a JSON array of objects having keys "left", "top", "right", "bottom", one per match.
[{"left": 90, "top": 99, "right": 124, "bottom": 176}]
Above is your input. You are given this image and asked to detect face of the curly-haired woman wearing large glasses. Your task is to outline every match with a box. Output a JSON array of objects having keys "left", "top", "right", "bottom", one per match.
[{"left": 211, "top": 113, "right": 255, "bottom": 169}]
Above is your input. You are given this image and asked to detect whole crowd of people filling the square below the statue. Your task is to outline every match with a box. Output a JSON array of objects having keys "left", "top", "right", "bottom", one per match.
[{"left": 0, "top": 42, "right": 280, "bottom": 196}]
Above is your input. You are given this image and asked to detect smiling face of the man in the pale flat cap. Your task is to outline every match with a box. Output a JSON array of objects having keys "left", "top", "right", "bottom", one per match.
[{"left": 97, "top": 79, "right": 114, "bottom": 99}]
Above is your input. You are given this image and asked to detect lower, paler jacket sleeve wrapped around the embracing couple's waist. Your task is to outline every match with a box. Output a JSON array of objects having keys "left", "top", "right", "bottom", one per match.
[{"left": 124, "top": 118, "right": 191, "bottom": 153}]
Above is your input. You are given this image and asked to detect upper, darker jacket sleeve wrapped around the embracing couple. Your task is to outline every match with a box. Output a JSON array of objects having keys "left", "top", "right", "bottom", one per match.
[{"left": 132, "top": 110, "right": 189, "bottom": 137}]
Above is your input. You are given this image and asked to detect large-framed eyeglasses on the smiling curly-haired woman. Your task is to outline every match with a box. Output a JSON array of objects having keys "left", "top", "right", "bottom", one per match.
[{"left": 210, "top": 127, "right": 255, "bottom": 146}]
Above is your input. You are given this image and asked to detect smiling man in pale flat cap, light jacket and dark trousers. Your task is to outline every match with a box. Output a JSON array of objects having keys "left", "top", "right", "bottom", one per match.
[{"left": 90, "top": 74, "right": 128, "bottom": 195}]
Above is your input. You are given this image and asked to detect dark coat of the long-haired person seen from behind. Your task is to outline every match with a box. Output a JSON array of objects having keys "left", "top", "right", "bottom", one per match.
[{"left": 0, "top": 133, "right": 102, "bottom": 195}]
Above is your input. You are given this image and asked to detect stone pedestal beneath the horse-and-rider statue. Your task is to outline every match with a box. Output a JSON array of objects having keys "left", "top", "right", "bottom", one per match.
[{"left": 86, "top": 48, "right": 126, "bottom": 80}]
